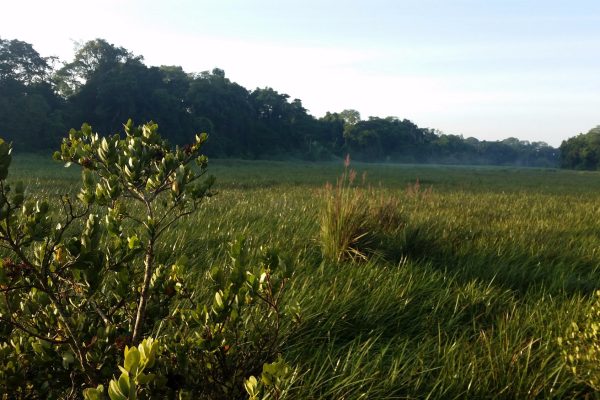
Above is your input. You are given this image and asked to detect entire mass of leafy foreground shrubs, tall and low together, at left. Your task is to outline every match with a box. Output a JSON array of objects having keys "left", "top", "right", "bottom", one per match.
[{"left": 0, "top": 121, "right": 291, "bottom": 400}]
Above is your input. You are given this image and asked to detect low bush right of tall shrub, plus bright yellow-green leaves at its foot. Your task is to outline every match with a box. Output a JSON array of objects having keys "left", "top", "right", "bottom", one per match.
[{"left": 84, "top": 239, "right": 299, "bottom": 400}]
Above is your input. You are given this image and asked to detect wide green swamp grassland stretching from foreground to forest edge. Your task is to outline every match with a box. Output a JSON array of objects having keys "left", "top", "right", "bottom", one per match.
[{"left": 9, "top": 155, "right": 600, "bottom": 399}]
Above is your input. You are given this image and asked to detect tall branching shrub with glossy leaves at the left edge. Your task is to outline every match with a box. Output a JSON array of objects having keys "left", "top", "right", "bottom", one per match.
[{"left": 0, "top": 121, "right": 212, "bottom": 395}]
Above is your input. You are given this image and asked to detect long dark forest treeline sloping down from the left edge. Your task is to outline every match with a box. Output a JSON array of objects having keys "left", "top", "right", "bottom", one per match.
[{"left": 0, "top": 38, "right": 564, "bottom": 166}]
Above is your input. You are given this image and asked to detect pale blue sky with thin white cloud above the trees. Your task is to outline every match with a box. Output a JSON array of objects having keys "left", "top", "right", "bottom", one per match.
[{"left": 0, "top": 0, "right": 600, "bottom": 146}]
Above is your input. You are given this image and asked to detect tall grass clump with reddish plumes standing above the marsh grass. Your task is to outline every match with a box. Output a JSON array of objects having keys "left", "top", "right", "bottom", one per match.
[{"left": 320, "top": 156, "right": 404, "bottom": 262}]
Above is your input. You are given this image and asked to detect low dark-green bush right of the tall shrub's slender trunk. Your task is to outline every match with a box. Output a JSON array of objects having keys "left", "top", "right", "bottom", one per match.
[{"left": 152, "top": 239, "right": 299, "bottom": 399}]
